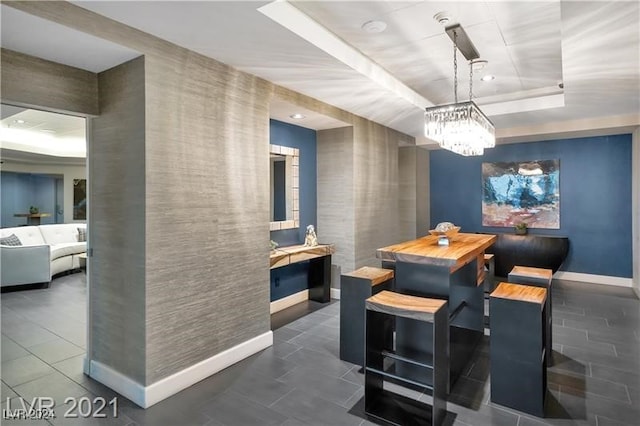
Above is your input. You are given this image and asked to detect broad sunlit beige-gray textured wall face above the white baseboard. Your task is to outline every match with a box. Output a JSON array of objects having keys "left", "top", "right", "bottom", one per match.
[{"left": 146, "top": 52, "right": 271, "bottom": 384}]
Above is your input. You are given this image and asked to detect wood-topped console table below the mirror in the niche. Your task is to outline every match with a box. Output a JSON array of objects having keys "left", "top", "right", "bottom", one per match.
[{"left": 270, "top": 244, "right": 336, "bottom": 303}]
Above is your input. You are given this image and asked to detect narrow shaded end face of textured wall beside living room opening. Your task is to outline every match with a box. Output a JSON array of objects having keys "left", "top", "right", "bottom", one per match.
[{"left": 88, "top": 58, "right": 148, "bottom": 383}]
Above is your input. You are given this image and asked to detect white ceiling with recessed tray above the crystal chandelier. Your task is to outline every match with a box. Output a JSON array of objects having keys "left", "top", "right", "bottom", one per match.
[{"left": 2, "top": 0, "right": 640, "bottom": 143}]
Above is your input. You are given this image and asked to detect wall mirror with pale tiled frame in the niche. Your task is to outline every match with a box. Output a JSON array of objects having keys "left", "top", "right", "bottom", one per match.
[{"left": 269, "top": 145, "right": 300, "bottom": 231}]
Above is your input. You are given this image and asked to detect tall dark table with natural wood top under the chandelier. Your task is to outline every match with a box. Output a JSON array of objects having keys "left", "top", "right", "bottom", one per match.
[{"left": 376, "top": 233, "right": 496, "bottom": 385}]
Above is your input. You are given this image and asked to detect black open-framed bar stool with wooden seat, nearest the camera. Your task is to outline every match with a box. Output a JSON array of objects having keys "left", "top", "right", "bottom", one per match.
[{"left": 364, "top": 290, "right": 449, "bottom": 425}]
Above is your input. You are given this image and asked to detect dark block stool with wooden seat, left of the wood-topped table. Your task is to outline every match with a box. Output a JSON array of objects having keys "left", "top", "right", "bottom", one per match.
[{"left": 340, "top": 266, "right": 394, "bottom": 366}]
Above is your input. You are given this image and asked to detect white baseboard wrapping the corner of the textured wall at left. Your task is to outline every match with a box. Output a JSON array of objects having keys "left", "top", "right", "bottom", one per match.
[{"left": 90, "top": 331, "right": 273, "bottom": 408}]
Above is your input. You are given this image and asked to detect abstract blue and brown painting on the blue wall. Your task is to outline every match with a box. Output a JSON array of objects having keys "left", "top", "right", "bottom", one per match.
[{"left": 482, "top": 160, "right": 560, "bottom": 229}]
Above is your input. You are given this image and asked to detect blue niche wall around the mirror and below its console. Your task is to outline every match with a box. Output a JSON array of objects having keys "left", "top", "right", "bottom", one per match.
[{"left": 270, "top": 120, "right": 320, "bottom": 301}]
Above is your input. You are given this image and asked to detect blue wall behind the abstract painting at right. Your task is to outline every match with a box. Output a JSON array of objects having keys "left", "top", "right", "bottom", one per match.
[{"left": 429, "top": 134, "right": 633, "bottom": 278}]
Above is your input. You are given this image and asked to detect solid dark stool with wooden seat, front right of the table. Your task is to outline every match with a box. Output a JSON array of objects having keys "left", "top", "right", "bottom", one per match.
[{"left": 489, "top": 283, "right": 547, "bottom": 417}]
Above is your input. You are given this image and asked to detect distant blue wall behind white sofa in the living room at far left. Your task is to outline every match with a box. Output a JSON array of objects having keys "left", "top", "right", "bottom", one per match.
[{"left": 0, "top": 172, "right": 56, "bottom": 228}]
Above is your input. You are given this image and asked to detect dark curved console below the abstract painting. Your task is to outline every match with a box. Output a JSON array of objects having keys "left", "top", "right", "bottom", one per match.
[{"left": 487, "top": 234, "right": 569, "bottom": 277}]
